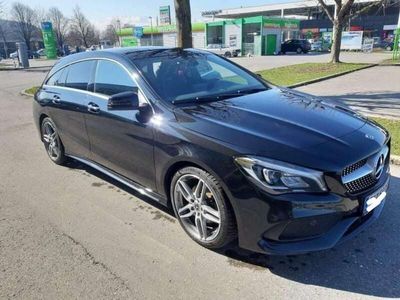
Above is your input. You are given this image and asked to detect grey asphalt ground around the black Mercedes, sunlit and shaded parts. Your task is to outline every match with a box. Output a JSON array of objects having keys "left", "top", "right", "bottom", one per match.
[{"left": 0, "top": 71, "right": 400, "bottom": 299}]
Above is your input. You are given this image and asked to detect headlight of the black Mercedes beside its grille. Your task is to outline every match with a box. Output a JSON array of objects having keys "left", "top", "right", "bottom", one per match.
[{"left": 235, "top": 156, "right": 327, "bottom": 194}]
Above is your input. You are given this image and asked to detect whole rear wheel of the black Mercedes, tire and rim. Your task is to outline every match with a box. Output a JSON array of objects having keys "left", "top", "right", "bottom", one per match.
[{"left": 40, "top": 117, "right": 67, "bottom": 165}]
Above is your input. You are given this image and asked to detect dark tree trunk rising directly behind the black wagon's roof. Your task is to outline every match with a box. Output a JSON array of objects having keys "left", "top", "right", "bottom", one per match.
[{"left": 175, "top": 0, "right": 193, "bottom": 48}]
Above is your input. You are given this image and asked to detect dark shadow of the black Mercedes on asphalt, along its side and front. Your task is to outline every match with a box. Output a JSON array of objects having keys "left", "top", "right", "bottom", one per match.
[{"left": 66, "top": 160, "right": 400, "bottom": 298}]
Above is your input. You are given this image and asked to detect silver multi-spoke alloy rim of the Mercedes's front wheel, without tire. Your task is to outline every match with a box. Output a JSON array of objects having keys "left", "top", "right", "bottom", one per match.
[{"left": 173, "top": 174, "right": 221, "bottom": 242}]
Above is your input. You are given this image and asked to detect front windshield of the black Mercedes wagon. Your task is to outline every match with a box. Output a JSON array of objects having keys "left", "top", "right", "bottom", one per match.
[{"left": 127, "top": 49, "right": 268, "bottom": 104}]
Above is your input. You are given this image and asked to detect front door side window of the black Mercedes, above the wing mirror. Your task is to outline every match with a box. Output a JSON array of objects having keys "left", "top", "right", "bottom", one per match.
[{"left": 95, "top": 60, "right": 136, "bottom": 96}]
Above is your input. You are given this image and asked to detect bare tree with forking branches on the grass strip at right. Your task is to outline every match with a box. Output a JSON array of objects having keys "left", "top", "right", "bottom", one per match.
[{"left": 318, "top": 0, "right": 386, "bottom": 63}]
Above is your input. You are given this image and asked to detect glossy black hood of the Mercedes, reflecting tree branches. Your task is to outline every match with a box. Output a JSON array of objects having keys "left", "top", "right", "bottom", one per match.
[{"left": 177, "top": 88, "right": 386, "bottom": 170}]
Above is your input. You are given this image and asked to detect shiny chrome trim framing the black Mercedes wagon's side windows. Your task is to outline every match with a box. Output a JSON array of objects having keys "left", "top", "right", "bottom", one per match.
[{"left": 43, "top": 57, "right": 155, "bottom": 113}]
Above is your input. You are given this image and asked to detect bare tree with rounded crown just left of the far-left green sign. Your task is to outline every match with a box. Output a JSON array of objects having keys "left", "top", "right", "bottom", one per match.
[{"left": 11, "top": 2, "right": 37, "bottom": 50}]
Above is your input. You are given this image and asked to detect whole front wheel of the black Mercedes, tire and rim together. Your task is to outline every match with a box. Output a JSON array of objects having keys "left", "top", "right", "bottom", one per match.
[{"left": 170, "top": 167, "right": 237, "bottom": 249}]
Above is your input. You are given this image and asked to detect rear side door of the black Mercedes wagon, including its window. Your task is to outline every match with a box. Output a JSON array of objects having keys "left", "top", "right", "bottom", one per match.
[{"left": 43, "top": 60, "right": 95, "bottom": 158}]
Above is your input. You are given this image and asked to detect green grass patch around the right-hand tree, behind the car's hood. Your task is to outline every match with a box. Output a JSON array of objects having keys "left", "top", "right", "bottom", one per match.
[{"left": 257, "top": 63, "right": 367, "bottom": 86}]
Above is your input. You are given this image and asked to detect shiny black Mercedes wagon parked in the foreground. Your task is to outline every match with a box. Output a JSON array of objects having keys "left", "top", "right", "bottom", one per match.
[{"left": 33, "top": 47, "right": 390, "bottom": 255}]
